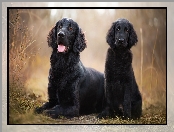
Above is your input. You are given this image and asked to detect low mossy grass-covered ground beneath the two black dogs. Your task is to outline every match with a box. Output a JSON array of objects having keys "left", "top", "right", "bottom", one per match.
[{"left": 9, "top": 87, "right": 166, "bottom": 124}]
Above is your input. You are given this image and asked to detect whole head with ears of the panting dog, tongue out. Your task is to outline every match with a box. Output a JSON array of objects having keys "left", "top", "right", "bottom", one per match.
[{"left": 47, "top": 18, "right": 86, "bottom": 53}]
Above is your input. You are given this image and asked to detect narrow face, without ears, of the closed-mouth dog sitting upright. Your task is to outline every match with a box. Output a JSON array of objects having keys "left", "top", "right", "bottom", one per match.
[{"left": 114, "top": 19, "right": 130, "bottom": 47}]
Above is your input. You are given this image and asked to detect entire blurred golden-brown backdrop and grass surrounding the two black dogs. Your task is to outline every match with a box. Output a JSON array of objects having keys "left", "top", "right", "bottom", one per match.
[{"left": 8, "top": 9, "right": 166, "bottom": 124}]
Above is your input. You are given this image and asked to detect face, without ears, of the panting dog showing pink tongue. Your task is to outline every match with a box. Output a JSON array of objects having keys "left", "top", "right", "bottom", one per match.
[{"left": 55, "top": 18, "right": 78, "bottom": 53}]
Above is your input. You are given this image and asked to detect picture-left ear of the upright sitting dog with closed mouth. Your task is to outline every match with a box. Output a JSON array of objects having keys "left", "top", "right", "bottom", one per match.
[{"left": 106, "top": 23, "right": 116, "bottom": 48}]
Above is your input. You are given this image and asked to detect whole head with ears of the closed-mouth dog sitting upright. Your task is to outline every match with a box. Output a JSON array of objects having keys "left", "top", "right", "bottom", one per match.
[{"left": 106, "top": 18, "right": 138, "bottom": 49}]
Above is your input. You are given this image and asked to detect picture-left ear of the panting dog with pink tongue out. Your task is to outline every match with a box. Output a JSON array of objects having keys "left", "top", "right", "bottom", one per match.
[{"left": 47, "top": 22, "right": 58, "bottom": 49}]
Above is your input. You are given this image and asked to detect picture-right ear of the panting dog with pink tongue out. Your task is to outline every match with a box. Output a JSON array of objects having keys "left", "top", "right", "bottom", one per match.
[{"left": 73, "top": 28, "right": 86, "bottom": 52}]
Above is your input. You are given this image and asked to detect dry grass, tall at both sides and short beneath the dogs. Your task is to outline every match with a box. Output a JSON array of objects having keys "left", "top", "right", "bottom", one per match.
[{"left": 8, "top": 10, "right": 166, "bottom": 124}]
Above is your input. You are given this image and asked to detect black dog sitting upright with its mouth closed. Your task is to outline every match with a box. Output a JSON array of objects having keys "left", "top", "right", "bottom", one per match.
[{"left": 98, "top": 19, "right": 142, "bottom": 119}]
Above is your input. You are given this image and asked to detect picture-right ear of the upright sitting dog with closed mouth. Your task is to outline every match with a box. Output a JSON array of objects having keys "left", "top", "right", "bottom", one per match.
[{"left": 128, "top": 23, "right": 138, "bottom": 49}]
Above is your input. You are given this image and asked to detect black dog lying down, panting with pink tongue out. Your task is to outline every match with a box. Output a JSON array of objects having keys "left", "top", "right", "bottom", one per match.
[{"left": 36, "top": 18, "right": 104, "bottom": 118}]
